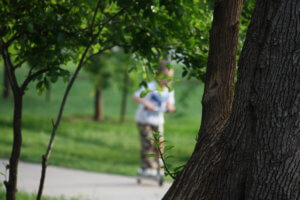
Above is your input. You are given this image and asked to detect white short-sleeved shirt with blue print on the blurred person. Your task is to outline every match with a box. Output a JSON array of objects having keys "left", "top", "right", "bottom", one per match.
[{"left": 134, "top": 81, "right": 175, "bottom": 126}]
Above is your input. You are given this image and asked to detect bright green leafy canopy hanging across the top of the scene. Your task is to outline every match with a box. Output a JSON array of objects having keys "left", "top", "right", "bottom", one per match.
[{"left": 0, "top": 0, "right": 216, "bottom": 89}]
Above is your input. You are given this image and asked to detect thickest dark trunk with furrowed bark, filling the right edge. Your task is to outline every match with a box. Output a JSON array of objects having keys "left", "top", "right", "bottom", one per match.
[{"left": 165, "top": 0, "right": 300, "bottom": 200}]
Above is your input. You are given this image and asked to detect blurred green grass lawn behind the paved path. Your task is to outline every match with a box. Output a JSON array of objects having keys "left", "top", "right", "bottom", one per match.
[{"left": 0, "top": 67, "right": 203, "bottom": 175}]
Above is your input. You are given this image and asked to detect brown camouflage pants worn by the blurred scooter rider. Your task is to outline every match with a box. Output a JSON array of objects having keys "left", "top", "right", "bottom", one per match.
[{"left": 138, "top": 123, "right": 163, "bottom": 169}]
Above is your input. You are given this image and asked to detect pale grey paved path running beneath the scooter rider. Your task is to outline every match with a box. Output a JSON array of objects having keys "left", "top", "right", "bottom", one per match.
[{"left": 0, "top": 159, "right": 170, "bottom": 200}]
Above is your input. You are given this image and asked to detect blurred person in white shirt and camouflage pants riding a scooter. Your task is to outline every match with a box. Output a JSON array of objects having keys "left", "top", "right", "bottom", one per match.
[{"left": 133, "top": 59, "right": 176, "bottom": 176}]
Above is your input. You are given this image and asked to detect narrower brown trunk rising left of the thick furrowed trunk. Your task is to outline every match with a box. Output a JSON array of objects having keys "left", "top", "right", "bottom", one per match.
[{"left": 199, "top": 0, "right": 243, "bottom": 136}]
